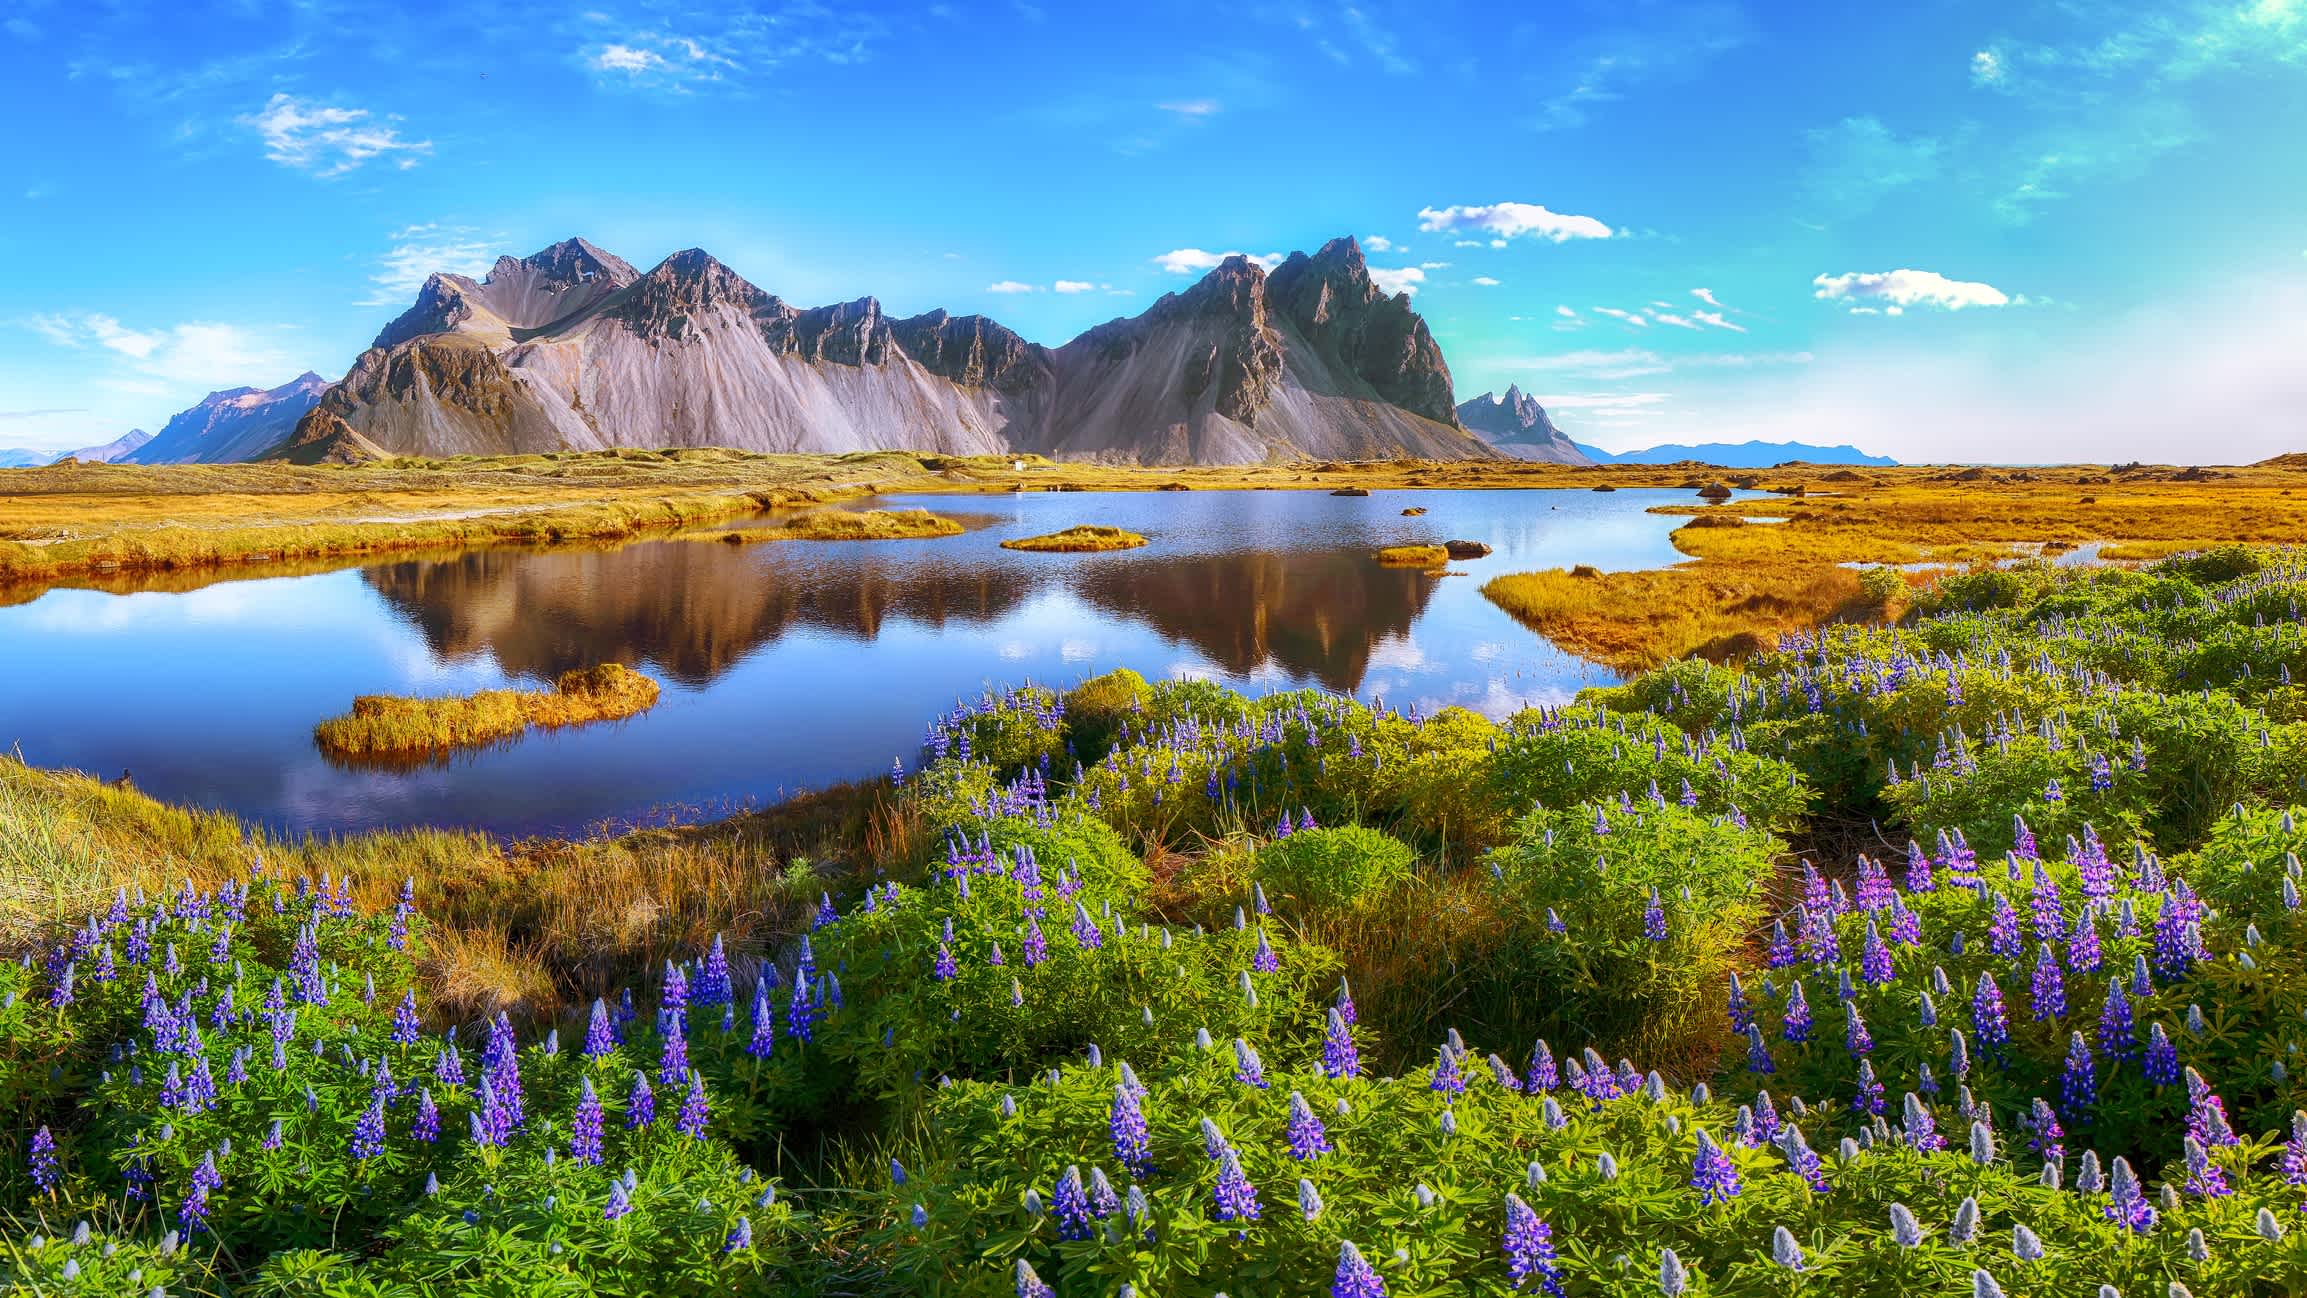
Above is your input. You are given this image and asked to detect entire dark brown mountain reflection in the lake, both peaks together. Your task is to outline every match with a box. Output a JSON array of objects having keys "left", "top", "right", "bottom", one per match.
[{"left": 362, "top": 542, "right": 1435, "bottom": 689}]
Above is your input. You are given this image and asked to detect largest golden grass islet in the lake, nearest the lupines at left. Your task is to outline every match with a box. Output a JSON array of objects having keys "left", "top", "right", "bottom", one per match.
[{"left": 311, "top": 662, "right": 660, "bottom": 761}]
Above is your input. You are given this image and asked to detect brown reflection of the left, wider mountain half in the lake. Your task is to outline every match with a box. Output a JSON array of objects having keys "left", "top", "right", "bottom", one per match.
[{"left": 362, "top": 542, "right": 1027, "bottom": 685}]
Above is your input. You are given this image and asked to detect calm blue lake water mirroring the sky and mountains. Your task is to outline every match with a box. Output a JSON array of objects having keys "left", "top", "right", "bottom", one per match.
[{"left": 0, "top": 491, "right": 1734, "bottom": 832}]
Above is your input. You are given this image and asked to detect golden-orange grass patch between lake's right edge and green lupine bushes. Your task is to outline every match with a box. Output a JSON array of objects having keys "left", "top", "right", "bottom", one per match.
[{"left": 1481, "top": 563, "right": 1883, "bottom": 671}]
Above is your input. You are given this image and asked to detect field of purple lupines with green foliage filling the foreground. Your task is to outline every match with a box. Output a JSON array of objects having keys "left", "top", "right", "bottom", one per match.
[{"left": 13, "top": 551, "right": 2307, "bottom": 1298}]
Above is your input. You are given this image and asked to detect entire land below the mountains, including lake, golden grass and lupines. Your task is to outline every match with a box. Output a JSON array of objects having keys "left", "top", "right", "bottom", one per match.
[{"left": 13, "top": 452, "right": 2307, "bottom": 1298}]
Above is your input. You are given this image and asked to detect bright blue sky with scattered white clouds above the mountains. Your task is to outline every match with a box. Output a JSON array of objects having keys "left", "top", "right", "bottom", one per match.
[{"left": 0, "top": 0, "right": 2307, "bottom": 461}]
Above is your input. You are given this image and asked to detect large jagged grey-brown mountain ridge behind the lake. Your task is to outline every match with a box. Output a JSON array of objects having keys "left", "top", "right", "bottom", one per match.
[{"left": 277, "top": 240, "right": 1495, "bottom": 463}]
